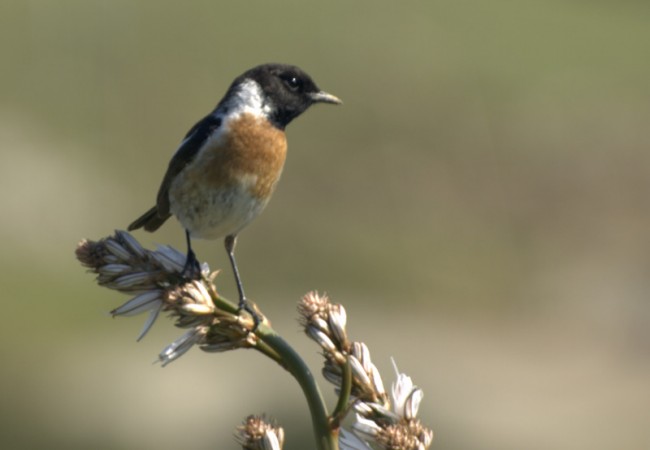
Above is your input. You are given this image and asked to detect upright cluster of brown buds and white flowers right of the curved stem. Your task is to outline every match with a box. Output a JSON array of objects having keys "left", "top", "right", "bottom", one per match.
[{"left": 298, "top": 292, "right": 433, "bottom": 450}]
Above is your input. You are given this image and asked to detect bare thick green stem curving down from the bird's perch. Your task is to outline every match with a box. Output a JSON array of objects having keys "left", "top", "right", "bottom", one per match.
[{"left": 256, "top": 324, "right": 339, "bottom": 450}]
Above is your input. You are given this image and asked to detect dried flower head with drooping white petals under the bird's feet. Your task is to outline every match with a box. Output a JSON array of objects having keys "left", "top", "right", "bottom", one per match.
[{"left": 76, "top": 230, "right": 257, "bottom": 366}]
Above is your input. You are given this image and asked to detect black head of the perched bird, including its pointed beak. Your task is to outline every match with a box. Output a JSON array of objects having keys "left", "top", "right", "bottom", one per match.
[{"left": 230, "top": 64, "right": 341, "bottom": 129}]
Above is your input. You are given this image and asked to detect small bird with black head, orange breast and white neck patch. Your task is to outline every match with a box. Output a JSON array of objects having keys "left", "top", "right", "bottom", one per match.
[{"left": 128, "top": 63, "right": 342, "bottom": 326}]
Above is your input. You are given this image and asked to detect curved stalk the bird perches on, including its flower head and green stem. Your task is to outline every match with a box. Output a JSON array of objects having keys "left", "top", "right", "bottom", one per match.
[{"left": 76, "top": 231, "right": 338, "bottom": 450}]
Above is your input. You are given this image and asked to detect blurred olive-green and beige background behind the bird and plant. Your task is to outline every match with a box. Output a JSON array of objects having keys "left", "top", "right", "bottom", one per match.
[{"left": 0, "top": 0, "right": 650, "bottom": 450}]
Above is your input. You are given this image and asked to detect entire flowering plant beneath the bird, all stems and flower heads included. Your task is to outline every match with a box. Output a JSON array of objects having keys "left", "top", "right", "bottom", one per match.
[{"left": 76, "top": 231, "right": 433, "bottom": 450}]
